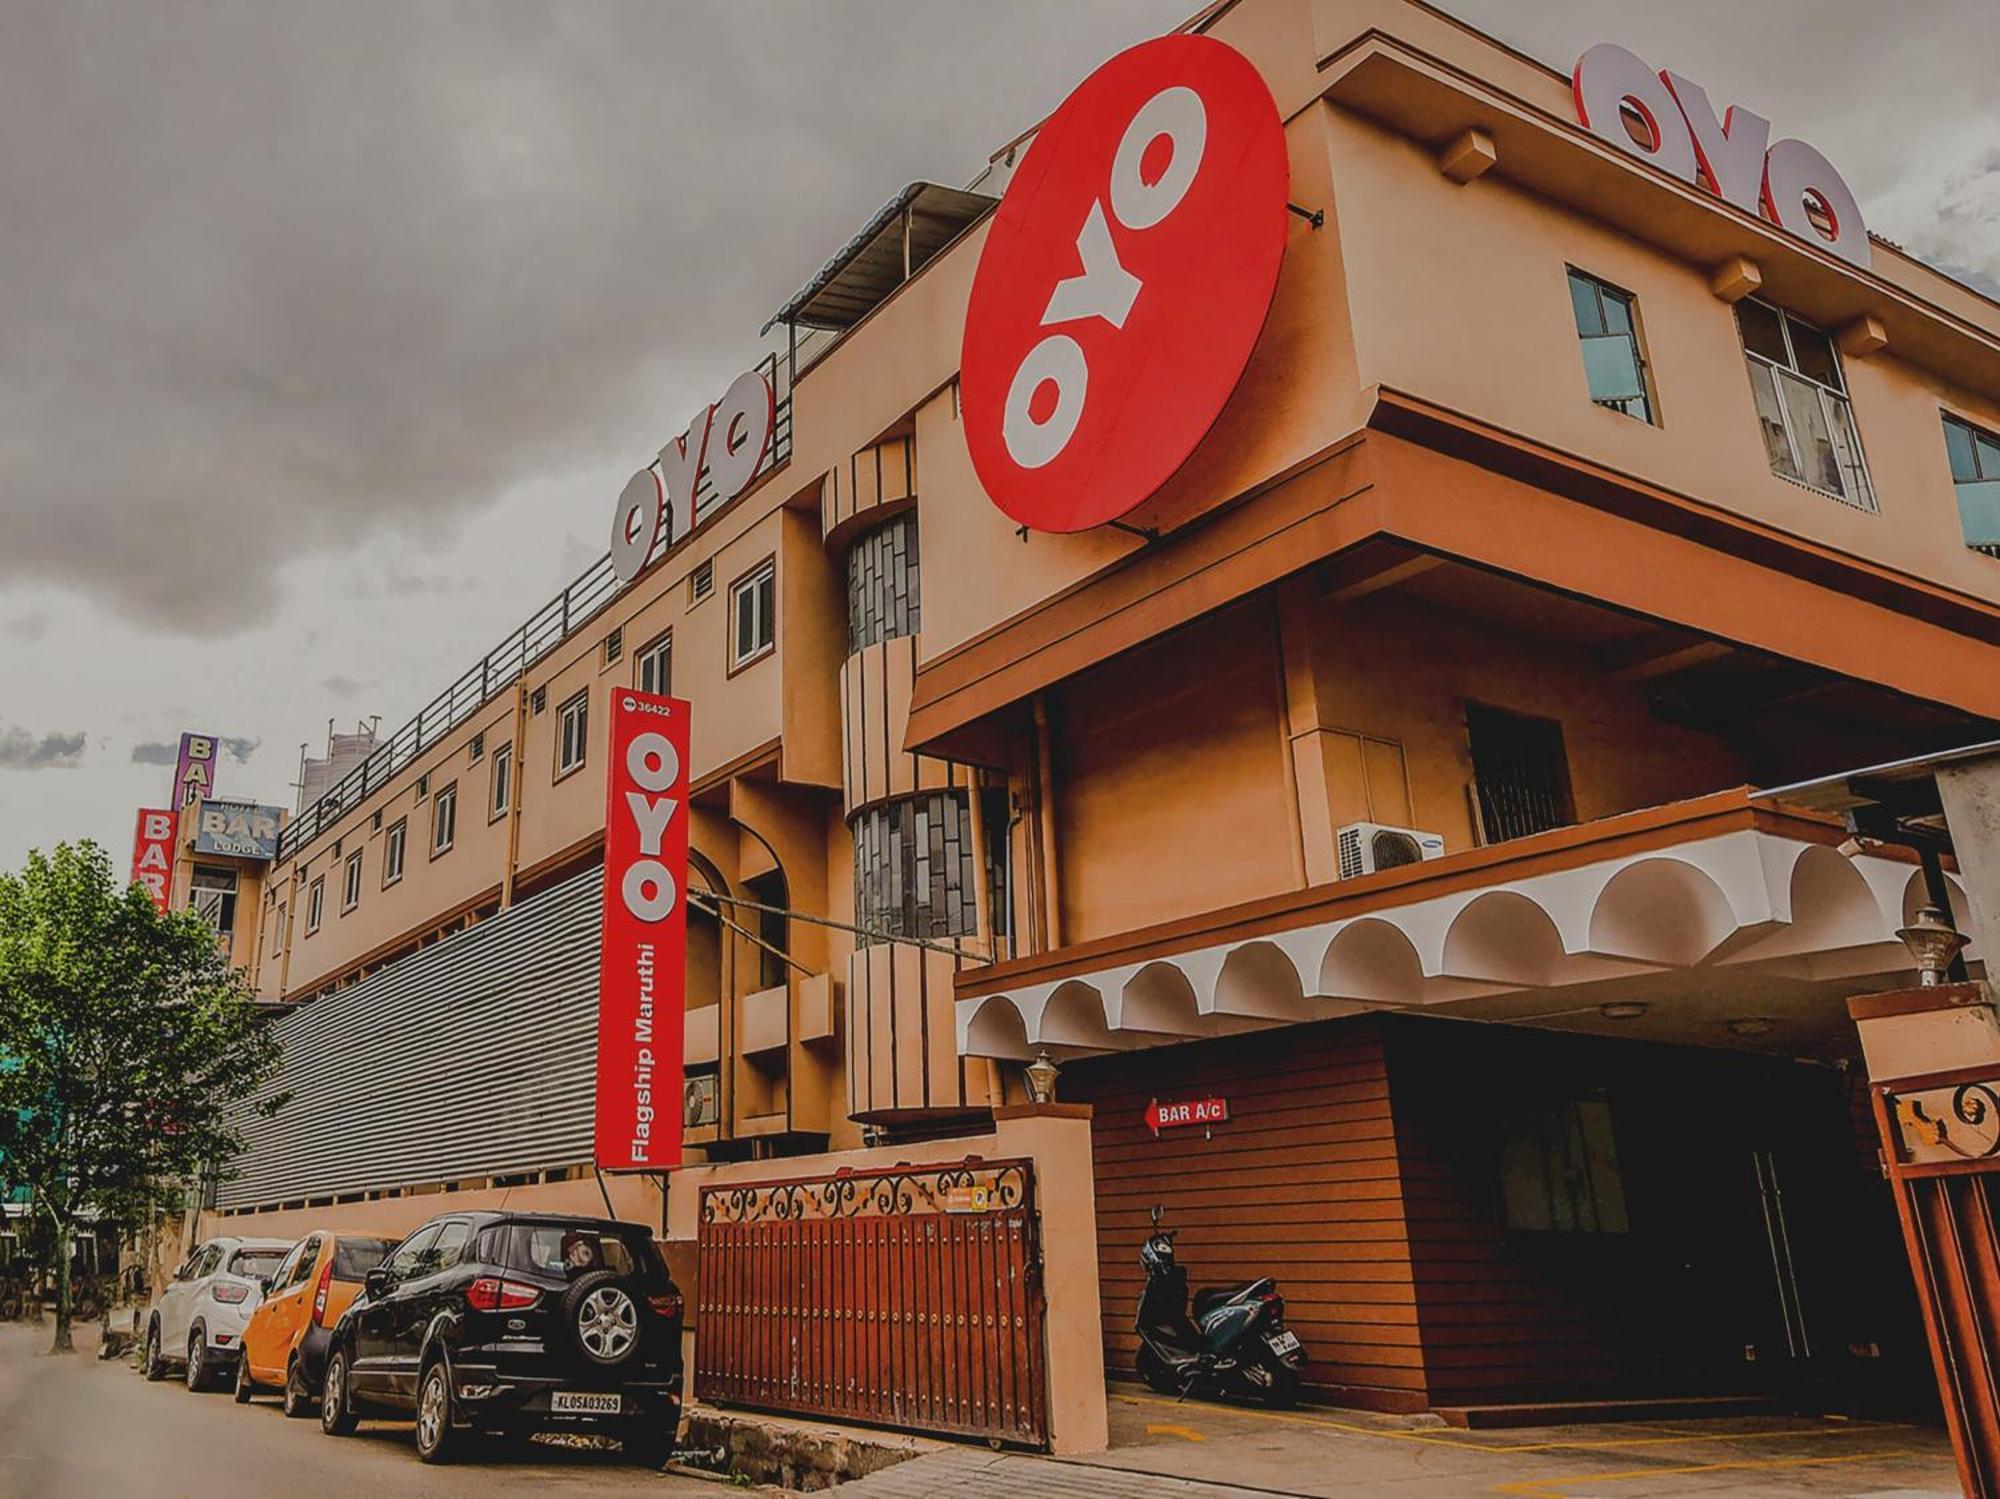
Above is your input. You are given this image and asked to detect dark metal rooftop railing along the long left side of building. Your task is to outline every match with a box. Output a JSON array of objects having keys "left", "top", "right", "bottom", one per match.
[{"left": 278, "top": 354, "right": 792, "bottom": 863}]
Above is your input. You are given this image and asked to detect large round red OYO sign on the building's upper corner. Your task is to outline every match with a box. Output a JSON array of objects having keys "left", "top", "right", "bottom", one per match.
[{"left": 960, "top": 36, "right": 1290, "bottom": 532}]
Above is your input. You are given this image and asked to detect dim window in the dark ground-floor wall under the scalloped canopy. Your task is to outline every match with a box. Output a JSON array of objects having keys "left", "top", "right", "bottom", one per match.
[{"left": 1500, "top": 1093, "right": 1626, "bottom": 1233}]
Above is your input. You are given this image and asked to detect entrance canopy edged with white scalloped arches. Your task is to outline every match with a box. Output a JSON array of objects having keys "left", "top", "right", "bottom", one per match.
[{"left": 956, "top": 789, "right": 1980, "bottom": 1059}]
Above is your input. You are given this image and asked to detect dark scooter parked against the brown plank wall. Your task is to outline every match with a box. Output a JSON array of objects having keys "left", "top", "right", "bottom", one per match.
[{"left": 1138, "top": 1207, "right": 1306, "bottom": 1407}]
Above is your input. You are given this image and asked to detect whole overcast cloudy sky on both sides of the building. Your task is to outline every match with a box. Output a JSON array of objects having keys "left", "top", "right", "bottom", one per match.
[{"left": 0, "top": 0, "right": 2000, "bottom": 865}]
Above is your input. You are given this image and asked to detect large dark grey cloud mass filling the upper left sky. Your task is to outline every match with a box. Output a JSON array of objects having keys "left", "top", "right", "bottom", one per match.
[{"left": 0, "top": 0, "right": 1190, "bottom": 634}]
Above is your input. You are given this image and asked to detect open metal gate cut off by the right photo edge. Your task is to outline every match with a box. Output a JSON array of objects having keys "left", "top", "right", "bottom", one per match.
[{"left": 1874, "top": 1067, "right": 2000, "bottom": 1499}]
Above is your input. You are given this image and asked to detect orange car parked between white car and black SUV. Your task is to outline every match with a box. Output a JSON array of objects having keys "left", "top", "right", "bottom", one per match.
[{"left": 236, "top": 1229, "right": 398, "bottom": 1415}]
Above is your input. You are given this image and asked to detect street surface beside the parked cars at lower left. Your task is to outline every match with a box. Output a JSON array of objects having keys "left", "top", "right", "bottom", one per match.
[{"left": 0, "top": 1323, "right": 718, "bottom": 1499}]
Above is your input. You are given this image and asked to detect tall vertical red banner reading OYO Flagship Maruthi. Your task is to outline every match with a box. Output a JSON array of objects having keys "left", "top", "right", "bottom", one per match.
[{"left": 596, "top": 692, "right": 688, "bottom": 1171}]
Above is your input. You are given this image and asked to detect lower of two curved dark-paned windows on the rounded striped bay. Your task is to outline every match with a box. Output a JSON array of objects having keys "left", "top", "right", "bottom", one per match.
[{"left": 854, "top": 791, "right": 978, "bottom": 943}]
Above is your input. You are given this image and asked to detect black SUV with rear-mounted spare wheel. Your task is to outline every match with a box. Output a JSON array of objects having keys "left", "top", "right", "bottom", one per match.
[{"left": 320, "top": 1213, "right": 680, "bottom": 1467}]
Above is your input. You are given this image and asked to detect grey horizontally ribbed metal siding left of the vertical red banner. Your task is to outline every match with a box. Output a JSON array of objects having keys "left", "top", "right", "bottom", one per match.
[{"left": 218, "top": 869, "right": 604, "bottom": 1207}]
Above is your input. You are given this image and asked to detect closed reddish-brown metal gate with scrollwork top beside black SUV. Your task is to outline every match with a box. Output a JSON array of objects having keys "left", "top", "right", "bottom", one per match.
[{"left": 694, "top": 1159, "right": 1048, "bottom": 1447}]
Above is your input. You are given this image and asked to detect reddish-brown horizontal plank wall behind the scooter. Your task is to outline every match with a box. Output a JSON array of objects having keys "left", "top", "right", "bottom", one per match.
[{"left": 1058, "top": 1019, "right": 1424, "bottom": 1411}]
